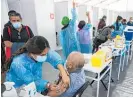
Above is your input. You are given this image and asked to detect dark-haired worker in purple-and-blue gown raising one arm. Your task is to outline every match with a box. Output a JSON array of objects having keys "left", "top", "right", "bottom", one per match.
[{"left": 77, "top": 12, "right": 92, "bottom": 53}]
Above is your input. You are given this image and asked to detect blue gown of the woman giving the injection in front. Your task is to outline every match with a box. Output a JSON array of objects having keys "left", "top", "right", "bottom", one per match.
[{"left": 6, "top": 50, "right": 63, "bottom": 92}]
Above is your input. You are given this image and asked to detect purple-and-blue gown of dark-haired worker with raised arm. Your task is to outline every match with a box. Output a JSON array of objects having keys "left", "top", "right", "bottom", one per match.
[{"left": 77, "top": 24, "right": 92, "bottom": 53}]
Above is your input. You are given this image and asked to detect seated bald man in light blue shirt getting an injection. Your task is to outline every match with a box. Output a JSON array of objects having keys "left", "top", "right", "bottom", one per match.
[{"left": 47, "top": 52, "right": 85, "bottom": 97}]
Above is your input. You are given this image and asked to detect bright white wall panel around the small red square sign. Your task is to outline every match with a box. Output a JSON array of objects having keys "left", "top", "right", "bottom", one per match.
[{"left": 34, "top": 0, "right": 56, "bottom": 49}]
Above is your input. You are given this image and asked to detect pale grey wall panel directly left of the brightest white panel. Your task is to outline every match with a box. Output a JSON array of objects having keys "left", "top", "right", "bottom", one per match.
[{"left": 20, "top": 0, "right": 38, "bottom": 35}]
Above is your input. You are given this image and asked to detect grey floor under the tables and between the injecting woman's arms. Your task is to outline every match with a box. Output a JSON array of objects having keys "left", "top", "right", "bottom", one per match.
[{"left": 43, "top": 51, "right": 133, "bottom": 97}]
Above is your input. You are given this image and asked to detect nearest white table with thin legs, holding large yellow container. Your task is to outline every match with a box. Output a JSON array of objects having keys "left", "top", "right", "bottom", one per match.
[{"left": 83, "top": 54, "right": 112, "bottom": 97}]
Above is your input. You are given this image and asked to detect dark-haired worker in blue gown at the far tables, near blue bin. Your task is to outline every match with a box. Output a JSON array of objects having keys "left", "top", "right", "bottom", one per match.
[{"left": 112, "top": 16, "right": 124, "bottom": 37}]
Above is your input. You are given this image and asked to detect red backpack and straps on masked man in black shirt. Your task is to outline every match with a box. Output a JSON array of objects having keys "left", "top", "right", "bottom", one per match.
[{"left": 6, "top": 26, "right": 30, "bottom": 60}]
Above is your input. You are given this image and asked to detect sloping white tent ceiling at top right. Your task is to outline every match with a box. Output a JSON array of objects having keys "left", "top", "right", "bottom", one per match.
[{"left": 54, "top": 0, "right": 133, "bottom": 12}]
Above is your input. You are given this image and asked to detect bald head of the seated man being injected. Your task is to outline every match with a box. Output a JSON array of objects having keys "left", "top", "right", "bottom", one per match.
[{"left": 66, "top": 52, "right": 85, "bottom": 72}]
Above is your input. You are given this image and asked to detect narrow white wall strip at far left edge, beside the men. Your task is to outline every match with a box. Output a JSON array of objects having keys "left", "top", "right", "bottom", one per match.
[{"left": 1, "top": 0, "right": 9, "bottom": 34}]
